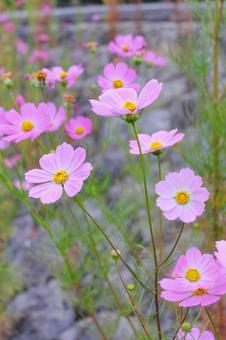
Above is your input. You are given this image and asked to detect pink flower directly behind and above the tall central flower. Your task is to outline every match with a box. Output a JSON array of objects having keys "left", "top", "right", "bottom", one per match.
[{"left": 98, "top": 63, "right": 140, "bottom": 91}]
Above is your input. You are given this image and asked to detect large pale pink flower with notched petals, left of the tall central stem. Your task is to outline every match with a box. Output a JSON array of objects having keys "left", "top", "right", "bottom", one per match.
[{"left": 25, "top": 143, "right": 93, "bottom": 204}]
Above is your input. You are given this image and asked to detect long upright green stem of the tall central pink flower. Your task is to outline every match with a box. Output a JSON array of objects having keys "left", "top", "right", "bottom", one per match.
[{"left": 132, "top": 121, "right": 162, "bottom": 340}]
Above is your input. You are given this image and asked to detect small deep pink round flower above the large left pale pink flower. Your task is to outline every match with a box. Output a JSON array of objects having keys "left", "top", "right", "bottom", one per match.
[{"left": 65, "top": 116, "right": 92, "bottom": 139}]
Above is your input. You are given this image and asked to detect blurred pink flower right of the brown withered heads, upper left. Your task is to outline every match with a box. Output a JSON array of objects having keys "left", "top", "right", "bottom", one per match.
[{"left": 51, "top": 65, "right": 84, "bottom": 88}]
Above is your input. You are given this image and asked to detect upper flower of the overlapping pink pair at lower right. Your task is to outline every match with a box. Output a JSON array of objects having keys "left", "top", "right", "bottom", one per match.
[{"left": 172, "top": 247, "right": 219, "bottom": 289}]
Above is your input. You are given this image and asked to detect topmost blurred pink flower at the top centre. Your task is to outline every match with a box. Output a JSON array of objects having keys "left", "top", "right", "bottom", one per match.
[{"left": 108, "top": 34, "right": 146, "bottom": 57}]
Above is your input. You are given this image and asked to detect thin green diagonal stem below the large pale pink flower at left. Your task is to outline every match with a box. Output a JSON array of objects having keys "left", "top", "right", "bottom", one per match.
[{"left": 75, "top": 197, "right": 154, "bottom": 295}]
